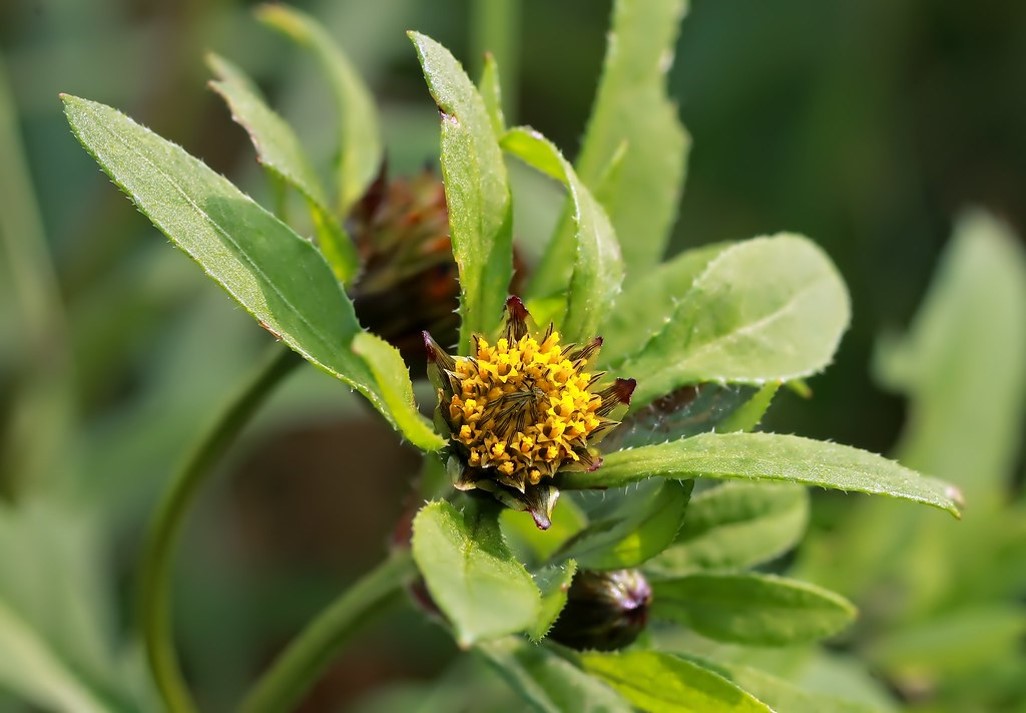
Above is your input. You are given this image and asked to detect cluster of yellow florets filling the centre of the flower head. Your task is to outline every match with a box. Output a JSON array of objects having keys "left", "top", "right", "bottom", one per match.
[{"left": 448, "top": 331, "right": 602, "bottom": 484}]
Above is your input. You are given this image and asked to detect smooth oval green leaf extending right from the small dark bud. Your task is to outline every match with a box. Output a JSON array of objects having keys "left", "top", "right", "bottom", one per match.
[{"left": 652, "top": 573, "right": 856, "bottom": 646}]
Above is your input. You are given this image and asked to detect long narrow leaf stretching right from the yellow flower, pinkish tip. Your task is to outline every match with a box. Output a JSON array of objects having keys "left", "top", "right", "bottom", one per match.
[{"left": 558, "top": 433, "right": 959, "bottom": 517}]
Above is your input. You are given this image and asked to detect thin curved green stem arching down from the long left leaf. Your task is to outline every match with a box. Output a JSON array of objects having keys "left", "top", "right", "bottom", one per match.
[{"left": 140, "top": 344, "right": 302, "bottom": 713}]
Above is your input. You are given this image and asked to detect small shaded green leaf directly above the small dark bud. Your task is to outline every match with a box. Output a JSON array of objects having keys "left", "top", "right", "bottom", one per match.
[{"left": 560, "top": 480, "right": 694, "bottom": 569}]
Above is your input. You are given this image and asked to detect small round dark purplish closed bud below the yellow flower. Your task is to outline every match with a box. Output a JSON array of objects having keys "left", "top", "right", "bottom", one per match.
[{"left": 549, "top": 569, "right": 652, "bottom": 651}]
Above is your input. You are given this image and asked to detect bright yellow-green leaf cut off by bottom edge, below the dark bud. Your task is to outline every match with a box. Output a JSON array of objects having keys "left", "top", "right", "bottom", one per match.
[{"left": 581, "top": 650, "right": 773, "bottom": 713}]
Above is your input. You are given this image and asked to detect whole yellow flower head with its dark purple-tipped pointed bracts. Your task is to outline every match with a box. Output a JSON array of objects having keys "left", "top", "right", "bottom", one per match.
[{"left": 424, "top": 296, "right": 636, "bottom": 529}]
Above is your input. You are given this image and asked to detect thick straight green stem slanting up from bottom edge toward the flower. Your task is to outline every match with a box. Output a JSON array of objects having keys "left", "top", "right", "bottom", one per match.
[{"left": 239, "top": 550, "right": 416, "bottom": 713}]
